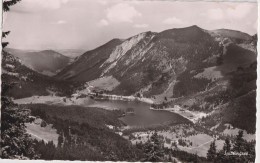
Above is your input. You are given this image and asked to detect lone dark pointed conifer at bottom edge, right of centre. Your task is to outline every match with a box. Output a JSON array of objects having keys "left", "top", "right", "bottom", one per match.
[{"left": 144, "top": 132, "right": 164, "bottom": 162}]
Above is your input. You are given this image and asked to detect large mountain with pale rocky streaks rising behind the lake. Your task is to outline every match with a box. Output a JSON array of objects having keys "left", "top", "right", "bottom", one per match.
[{"left": 55, "top": 26, "right": 257, "bottom": 133}]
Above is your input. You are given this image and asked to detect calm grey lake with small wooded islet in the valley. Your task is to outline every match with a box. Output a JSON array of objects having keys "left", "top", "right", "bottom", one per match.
[{"left": 86, "top": 100, "right": 188, "bottom": 127}]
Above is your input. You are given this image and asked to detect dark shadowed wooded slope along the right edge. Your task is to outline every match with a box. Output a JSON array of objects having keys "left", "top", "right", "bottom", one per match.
[{"left": 220, "top": 62, "right": 257, "bottom": 133}]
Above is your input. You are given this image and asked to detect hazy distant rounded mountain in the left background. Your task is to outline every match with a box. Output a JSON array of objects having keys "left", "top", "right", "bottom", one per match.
[{"left": 5, "top": 48, "right": 72, "bottom": 76}]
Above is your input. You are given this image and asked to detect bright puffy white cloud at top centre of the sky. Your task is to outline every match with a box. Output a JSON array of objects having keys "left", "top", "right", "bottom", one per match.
[{"left": 107, "top": 3, "right": 142, "bottom": 23}]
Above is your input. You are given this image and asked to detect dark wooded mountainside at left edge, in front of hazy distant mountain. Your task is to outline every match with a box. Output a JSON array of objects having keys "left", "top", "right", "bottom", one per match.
[{"left": 1, "top": 51, "right": 80, "bottom": 99}]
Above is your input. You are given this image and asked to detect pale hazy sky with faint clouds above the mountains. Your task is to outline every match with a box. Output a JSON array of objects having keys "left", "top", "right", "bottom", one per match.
[{"left": 4, "top": 0, "right": 257, "bottom": 50}]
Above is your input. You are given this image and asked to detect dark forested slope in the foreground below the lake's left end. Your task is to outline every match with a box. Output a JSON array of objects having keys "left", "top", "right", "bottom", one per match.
[{"left": 26, "top": 104, "right": 143, "bottom": 161}]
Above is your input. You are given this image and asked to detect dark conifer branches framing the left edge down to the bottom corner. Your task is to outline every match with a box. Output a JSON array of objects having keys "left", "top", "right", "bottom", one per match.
[{"left": 0, "top": 0, "right": 38, "bottom": 159}]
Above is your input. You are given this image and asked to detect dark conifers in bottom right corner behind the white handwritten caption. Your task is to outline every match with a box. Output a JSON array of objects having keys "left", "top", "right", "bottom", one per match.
[{"left": 207, "top": 131, "right": 255, "bottom": 163}]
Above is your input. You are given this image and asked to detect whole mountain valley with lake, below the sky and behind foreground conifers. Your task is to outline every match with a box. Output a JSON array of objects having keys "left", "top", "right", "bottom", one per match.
[{"left": 2, "top": 25, "right": 257, "bottom": 162}]
